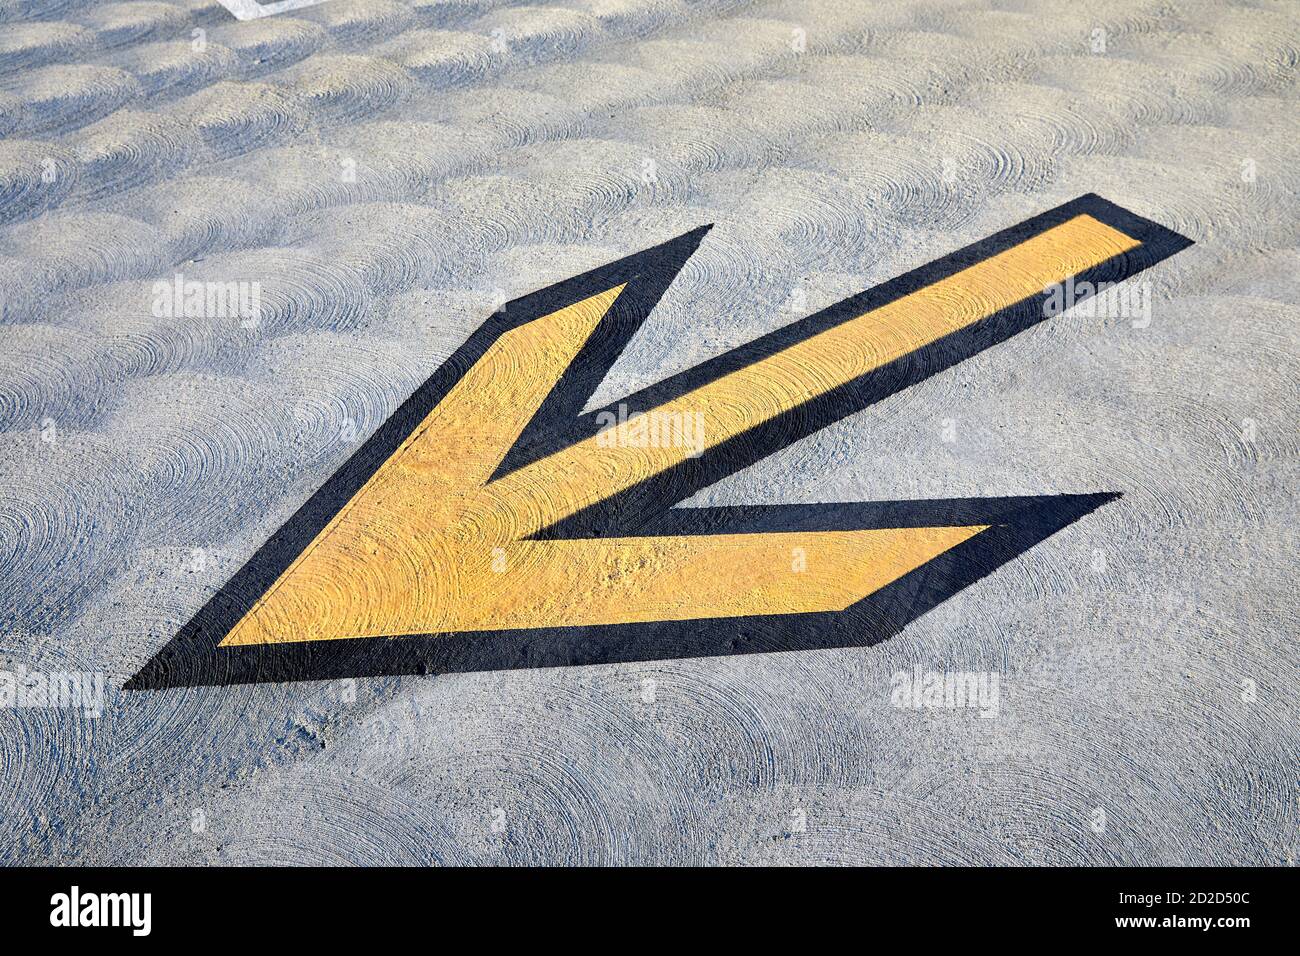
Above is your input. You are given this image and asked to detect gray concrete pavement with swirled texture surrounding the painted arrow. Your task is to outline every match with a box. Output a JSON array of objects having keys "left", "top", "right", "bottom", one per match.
[{"left": 0, "top": 0, "right": 1300, "bottom": 865}]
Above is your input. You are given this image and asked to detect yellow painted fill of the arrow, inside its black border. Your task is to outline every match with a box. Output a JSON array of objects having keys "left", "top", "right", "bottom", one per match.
[{"left": 221, "top": 215, "right": 1139, "bottom": 646}]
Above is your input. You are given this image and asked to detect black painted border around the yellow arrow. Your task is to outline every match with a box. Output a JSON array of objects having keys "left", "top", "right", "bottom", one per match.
[{"left": 125, "top": 194, "right": 1192, "bottom": 689}]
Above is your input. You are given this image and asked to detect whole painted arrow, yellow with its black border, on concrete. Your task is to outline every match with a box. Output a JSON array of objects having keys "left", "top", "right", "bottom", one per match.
[{"left": 133, "top": 198, "right": 1187, "bottom": 685}]
